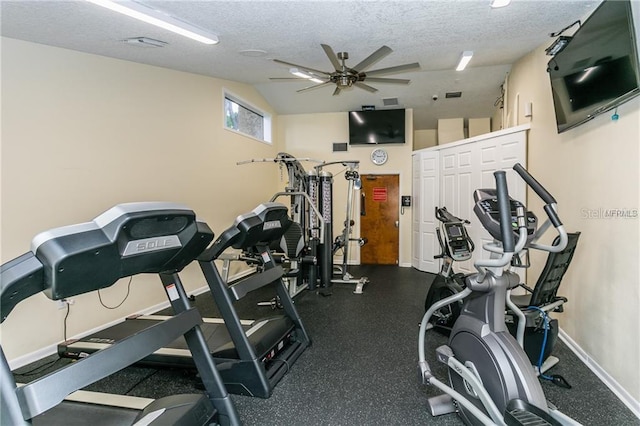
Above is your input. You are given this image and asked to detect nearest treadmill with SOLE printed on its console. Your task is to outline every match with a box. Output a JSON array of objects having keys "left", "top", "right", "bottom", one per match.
[{"left": 0, "top": 203, "right": 240, "bottom": 426}]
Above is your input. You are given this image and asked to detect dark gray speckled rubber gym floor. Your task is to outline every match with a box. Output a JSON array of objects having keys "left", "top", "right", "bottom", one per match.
[{"left": 12, "top": 266, "right": 640, "bottom": 426}]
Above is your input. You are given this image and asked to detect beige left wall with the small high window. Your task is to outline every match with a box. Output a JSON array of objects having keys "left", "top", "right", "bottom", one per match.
[{"left": 1, "top": 38, "right": 279, "bottom": 359}]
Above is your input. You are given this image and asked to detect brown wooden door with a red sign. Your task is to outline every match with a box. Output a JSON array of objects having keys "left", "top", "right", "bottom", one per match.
[{"left": 360, "top": 175, "right": 400, "bottom": 265}]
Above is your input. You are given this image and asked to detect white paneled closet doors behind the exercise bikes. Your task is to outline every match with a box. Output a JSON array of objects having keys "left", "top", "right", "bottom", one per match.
[{"left": 412, "top": 126, "right": 528, "bottom": 278}]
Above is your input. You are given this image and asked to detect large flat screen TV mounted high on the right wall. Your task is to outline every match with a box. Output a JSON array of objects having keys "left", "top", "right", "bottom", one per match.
[{"left": 547, "top": 0, "right": 640, "bottom": 133}]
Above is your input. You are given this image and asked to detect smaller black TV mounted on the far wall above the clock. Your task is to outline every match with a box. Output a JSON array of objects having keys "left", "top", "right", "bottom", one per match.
[{"left": 349, "top": 109, "right": 405, "bottom": 145}]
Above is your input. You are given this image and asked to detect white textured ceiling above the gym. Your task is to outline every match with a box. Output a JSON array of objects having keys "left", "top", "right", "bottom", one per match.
[{"left": 0, "top": 0, "right": 600, "bottom": 129}]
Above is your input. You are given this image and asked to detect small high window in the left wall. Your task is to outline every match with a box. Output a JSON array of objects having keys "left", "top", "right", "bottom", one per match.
[{"left": 224, "top": 92, "right": 271, "bottom": 143}]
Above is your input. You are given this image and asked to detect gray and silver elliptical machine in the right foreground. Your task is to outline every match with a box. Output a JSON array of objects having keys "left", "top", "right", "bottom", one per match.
[{"left": 418, "top": 164, "right": 579, "bottom": 425}]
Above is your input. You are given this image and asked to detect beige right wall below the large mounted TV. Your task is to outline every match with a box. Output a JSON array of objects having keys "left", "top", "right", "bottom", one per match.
[{"left": 506, "top": 48, "right": 640, "bottom": 401}]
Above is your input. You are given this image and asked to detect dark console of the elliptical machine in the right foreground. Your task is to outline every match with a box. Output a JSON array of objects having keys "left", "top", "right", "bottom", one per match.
[{"left": 473, "top": 189, "right": 538, "bottom": 242}]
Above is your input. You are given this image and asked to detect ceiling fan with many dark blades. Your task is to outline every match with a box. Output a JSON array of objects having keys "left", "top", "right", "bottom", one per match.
[{"left": 270, "top": 44, "right": 420, "bottom": 96}]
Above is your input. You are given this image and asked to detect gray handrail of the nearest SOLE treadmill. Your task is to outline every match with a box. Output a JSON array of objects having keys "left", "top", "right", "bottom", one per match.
[{"left": 15, "top": 308, "right": 202, "bottom": 419}]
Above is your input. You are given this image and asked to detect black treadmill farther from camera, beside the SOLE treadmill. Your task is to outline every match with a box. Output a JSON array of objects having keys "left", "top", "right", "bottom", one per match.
[{"left": 58, "top": 202, "right": 311, "bottom": 398}]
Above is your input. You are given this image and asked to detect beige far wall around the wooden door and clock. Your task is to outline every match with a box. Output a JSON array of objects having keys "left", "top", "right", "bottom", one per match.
[{"left": 278, "top": 109, "right": 413, "bottom": 268}]
